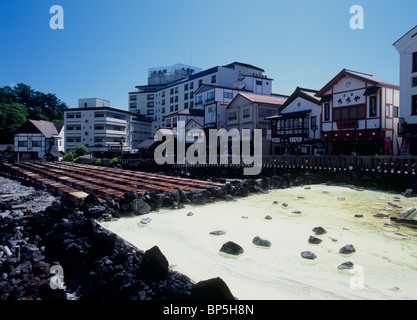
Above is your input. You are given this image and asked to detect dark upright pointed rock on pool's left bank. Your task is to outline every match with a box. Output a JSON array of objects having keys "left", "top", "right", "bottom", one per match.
[{"left": 139, "top": 246, "right": 169, "bottom": 280}]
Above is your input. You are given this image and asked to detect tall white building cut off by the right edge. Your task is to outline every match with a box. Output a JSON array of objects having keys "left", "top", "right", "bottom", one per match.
[{"left": 394, "top": 26, "right": 417, "bottom": 155}]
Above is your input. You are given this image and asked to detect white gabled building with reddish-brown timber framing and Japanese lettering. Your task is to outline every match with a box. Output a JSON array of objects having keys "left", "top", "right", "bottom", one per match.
[{"left": 317, "top": 69, "right": 400, "bottom": 155}]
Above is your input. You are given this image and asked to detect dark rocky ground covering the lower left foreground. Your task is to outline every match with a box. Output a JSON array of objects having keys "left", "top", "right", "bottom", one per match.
[{"left": 0, "top": 177, "right": 234, "bottom": 300}]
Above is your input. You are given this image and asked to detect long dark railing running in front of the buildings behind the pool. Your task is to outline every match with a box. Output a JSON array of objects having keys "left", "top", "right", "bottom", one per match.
[{"left": 122, "top": 155, "right": 417, "bottom": 176}]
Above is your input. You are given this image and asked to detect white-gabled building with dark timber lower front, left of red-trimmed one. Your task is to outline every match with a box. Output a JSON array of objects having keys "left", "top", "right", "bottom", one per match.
[{"left": 268, "top": 87, "right": 324, "bottom": 155}]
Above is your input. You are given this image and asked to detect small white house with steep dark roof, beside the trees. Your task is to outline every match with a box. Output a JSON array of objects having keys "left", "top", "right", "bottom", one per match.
[{"left": 14, "top": 120, "right": 65, "bottom": 161}]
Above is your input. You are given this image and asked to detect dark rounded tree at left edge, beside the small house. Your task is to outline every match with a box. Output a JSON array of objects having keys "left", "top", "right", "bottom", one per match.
[{"left": 0, "top": 102, "right": 28, "bottom": 143}]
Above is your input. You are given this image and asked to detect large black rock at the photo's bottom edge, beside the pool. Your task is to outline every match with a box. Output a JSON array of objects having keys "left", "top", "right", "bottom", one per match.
[{"left": 190, "top": 278, "right": 235, "bottom": 300}]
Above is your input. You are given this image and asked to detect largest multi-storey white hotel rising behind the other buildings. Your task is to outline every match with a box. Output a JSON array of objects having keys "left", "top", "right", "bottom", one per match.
[{"left": 129, "top": 62, "right": 273, "bottom": 133}]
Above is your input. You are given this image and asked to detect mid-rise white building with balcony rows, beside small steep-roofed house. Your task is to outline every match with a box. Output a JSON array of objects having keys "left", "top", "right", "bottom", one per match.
[{"left": 64, "top": 99, "right": 151, "bottom": 156}]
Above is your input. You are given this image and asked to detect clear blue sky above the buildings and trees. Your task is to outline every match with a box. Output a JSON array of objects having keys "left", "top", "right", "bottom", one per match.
[{"left": 0, "top": 0, "right": 417, "bottom": 109}]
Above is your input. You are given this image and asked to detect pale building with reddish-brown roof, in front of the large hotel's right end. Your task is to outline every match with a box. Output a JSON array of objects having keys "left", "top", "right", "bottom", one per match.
[{"left": 227, "top": 92, "right": 287, "bottom": 155}]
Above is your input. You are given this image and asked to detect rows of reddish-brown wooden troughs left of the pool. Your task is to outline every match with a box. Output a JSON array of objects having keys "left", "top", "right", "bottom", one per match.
[{"left": 1, "top": 162, "right": 223, "bottom": 202}]
